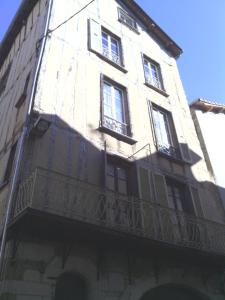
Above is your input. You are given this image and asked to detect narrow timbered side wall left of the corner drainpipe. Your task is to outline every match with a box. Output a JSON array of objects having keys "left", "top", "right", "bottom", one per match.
[{"left": 0, "top": 0, "right": 47, "bottom": 232}]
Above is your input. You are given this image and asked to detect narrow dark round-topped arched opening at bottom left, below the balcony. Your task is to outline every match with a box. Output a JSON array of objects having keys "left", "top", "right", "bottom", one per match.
[{"left": 55, "top": 273, "right": 86, "bottom": 300}]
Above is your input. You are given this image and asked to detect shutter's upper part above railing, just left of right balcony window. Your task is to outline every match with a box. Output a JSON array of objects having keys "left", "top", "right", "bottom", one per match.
[{"left": 153, "top": 173, "right": 168, "bottom": 206}]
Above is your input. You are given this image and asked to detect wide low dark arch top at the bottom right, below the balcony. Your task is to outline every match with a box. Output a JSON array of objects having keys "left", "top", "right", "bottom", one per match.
[{"left": 141, "top": 285, "right": 208, "bottom": 300}]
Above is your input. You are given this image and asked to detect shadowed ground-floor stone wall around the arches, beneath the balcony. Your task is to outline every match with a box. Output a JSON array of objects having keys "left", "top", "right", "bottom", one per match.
[{"left": 0, "top": 240, "right": 224, "bottom": 300}]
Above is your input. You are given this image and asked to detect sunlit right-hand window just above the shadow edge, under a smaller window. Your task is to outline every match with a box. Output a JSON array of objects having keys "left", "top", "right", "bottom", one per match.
[{"left": 150, "top": 103, "right": 181, "bottom": 159}]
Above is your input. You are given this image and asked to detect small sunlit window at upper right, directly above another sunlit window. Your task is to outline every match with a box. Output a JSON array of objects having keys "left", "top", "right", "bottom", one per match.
[{"left": 143, "top": 56, "right": 164, "bottom": 90}]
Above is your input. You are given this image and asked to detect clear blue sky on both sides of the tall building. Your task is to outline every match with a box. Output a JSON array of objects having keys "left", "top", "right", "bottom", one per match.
[{"left": 0, "top": 0, "right": 225, "bottom": 104}]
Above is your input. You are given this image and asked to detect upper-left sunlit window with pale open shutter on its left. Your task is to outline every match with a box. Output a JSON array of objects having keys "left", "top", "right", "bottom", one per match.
[{"left": 102, "top": 30, "right": 122, "bottom": 65}]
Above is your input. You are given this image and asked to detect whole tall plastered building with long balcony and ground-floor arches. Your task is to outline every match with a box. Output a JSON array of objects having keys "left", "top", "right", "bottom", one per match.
[{"left": 0, "top": 0, "right": 225, "bottom": 300}]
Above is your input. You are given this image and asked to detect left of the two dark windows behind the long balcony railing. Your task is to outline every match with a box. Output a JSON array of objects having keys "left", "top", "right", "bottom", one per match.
[{"left": 104, "top": 155, "right": 141, "bottom": 229}]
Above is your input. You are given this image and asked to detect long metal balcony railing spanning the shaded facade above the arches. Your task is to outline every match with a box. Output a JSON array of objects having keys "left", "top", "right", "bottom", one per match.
[{"left": 14, "top": 168, "right": 225, "bottom": 254}]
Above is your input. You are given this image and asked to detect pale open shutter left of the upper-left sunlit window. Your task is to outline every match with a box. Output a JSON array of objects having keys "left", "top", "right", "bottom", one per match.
[{"left": 89, "top": 19, "right": 102, "bottom": 53}]
